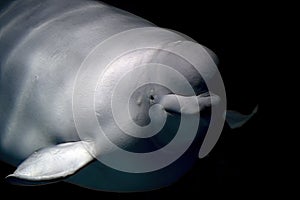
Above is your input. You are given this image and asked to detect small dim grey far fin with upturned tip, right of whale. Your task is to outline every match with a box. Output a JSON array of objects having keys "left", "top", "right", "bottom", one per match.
[{"left": 226, "top": 106, "right": 258, "bottom": 129}]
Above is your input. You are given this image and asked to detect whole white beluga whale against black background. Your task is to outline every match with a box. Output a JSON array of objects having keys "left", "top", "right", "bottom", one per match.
[{"left": 0, "top": 0, "right": 257, "bottom": 192}]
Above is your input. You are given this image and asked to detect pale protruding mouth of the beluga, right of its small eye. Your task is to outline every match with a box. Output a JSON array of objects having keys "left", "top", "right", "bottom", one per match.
[{"left": 159, "top": 93, "right": 220, "bottom": 115}]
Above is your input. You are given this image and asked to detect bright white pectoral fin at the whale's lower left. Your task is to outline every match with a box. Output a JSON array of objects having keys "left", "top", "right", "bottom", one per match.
[{"left": 6, "top": 141, "right": 93, "bottom": 185}]
